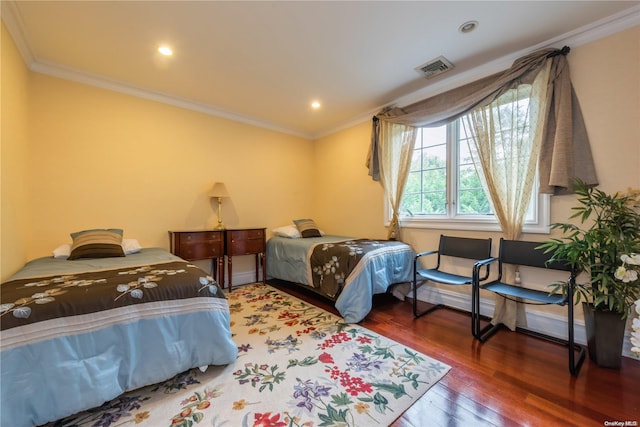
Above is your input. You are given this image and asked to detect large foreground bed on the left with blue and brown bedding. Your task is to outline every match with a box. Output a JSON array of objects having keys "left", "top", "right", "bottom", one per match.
[{"left": 0, "top": 248, "right": 237, "bottom": 427}]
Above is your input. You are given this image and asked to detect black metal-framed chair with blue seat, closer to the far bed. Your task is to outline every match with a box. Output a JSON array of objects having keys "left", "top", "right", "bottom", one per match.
[{"left": 412, "top": 235, "right": 491, "bottom": 317}]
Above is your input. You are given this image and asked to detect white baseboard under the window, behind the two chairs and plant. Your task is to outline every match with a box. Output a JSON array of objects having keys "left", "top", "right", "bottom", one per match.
[{"left": 418, "top": 286, "right": 638, "bottom": 359}]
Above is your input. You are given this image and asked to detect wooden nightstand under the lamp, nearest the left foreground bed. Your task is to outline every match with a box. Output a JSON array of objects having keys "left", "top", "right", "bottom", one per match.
[{"left": 169, "top": 230, "right": 224, "bottom": 287}]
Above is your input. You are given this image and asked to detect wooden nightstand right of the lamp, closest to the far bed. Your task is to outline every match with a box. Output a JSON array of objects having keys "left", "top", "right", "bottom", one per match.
[{"left": 224, "top": 228, "right": 267, "bottom": 291}]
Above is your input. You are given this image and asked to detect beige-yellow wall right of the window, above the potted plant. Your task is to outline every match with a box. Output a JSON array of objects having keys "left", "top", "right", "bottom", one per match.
[{"left": 568, "top": 26, "right": 640, "bottom": 192}]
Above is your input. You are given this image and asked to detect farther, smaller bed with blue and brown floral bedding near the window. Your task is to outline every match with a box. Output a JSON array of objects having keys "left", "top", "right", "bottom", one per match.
[{"left": 266, "top": 235, "right": 415, "bottom": 323}]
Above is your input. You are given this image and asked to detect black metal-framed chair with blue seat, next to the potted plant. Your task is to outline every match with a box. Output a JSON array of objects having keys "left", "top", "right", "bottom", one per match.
[{"left": 471, "top": 238, "right": 586, "bottom": 376}]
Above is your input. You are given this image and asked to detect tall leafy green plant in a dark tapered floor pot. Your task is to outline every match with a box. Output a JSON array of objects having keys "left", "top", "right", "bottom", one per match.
[{"left": 540, "top": 180, "right": 640, "bottom": 368}]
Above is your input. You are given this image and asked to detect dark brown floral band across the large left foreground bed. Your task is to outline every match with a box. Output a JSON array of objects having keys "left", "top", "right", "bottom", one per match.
[{"left": 0, "top": 261, "right": 225, "bottom": 331}]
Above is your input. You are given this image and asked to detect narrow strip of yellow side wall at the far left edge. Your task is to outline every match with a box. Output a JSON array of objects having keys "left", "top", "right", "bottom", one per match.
[{"left": 0, "top": 24, "right": 31, "bottom": 278}]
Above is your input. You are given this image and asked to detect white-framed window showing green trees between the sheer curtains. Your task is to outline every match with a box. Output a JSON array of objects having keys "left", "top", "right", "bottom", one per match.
[{"left": 400, "top": 121, "right": 550, "bottom": 233}]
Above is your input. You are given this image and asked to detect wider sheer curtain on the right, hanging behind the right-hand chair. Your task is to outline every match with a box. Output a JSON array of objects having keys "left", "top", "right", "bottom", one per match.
[{"left": 461, "top": 62, "right": 550, "bottom": 330}]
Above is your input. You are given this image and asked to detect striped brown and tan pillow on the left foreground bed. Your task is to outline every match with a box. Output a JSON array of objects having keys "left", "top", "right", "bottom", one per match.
[{"left": 67, "top": 228, "right": 125, "bottom": 260}]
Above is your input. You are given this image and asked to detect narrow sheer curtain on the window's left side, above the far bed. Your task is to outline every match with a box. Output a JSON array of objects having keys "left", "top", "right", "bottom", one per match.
[{"left": 377, "top": 120, "right": 418, "bottom": 240}]
